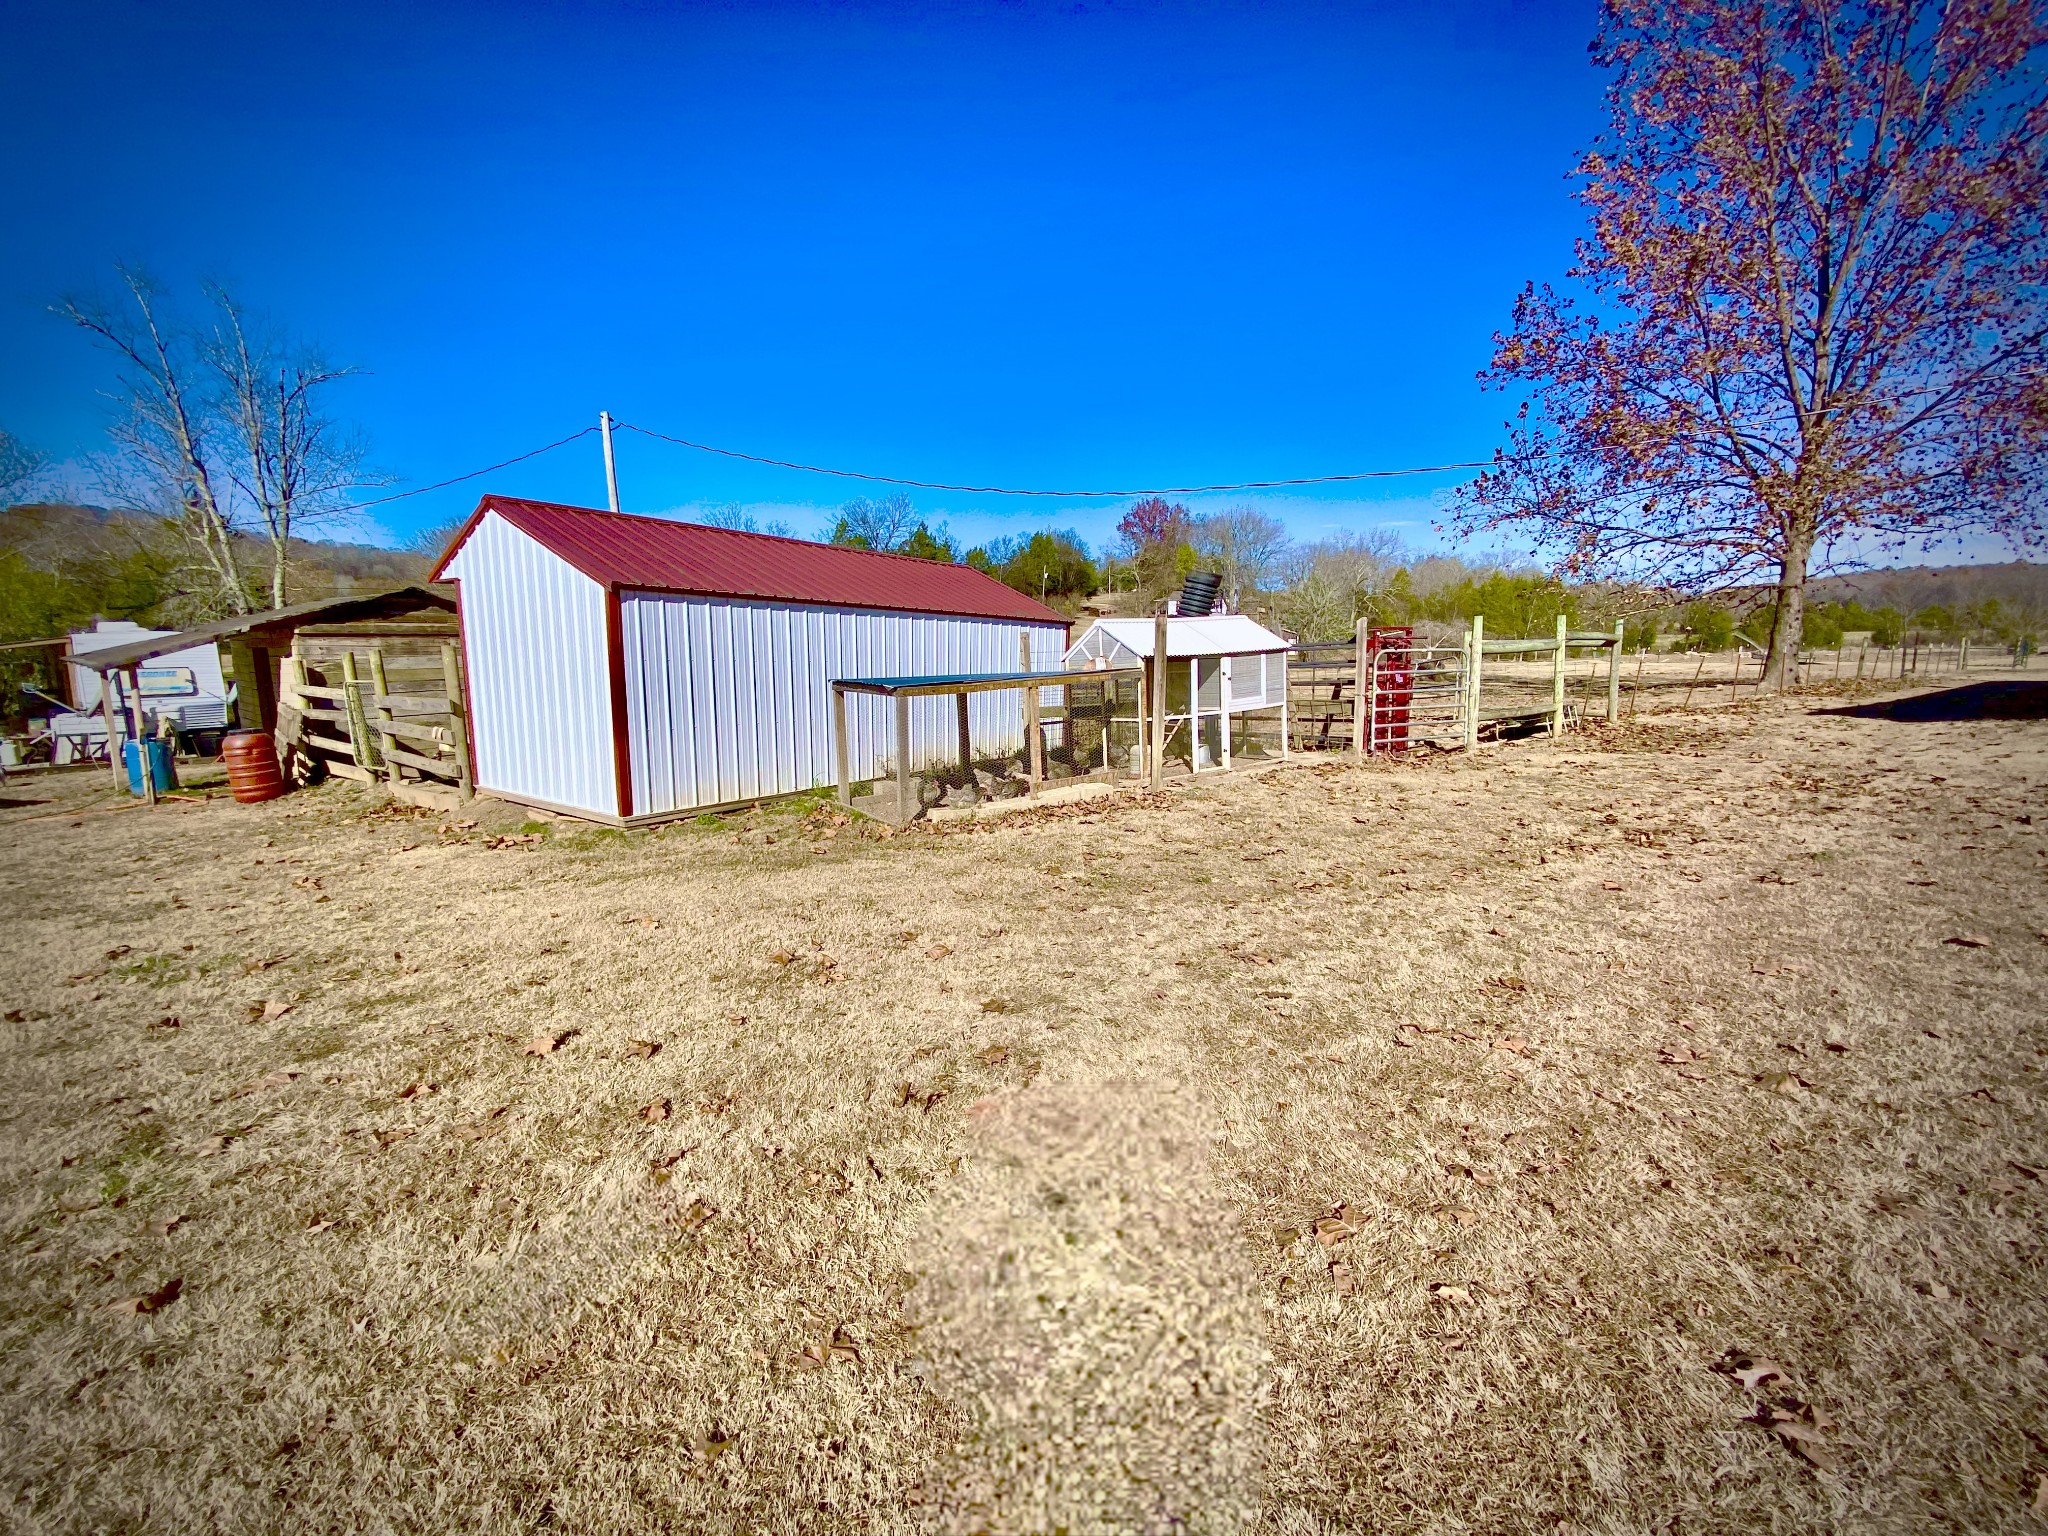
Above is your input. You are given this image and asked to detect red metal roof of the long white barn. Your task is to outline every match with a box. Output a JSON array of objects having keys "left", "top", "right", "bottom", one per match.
[{"left": 434, "top": 496, "right": 1069, "bottom": 625}]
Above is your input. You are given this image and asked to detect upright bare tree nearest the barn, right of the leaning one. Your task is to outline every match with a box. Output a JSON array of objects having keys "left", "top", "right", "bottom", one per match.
[{"left": 201, "top": 283, "right": 385, "bottom": 608}]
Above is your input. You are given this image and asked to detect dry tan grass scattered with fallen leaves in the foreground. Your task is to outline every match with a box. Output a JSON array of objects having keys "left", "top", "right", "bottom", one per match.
[{"left": 0, "top": 700, "right": 2048, "bottom": 1532}]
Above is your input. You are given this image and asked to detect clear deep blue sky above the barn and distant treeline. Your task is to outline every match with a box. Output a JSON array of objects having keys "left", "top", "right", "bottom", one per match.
[{"left": 0, "top": 0, "right": 1602, "bottom": 561}]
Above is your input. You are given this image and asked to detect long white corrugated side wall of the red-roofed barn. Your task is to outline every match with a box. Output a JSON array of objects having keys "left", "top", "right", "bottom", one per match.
[{"left": 618, "top": 592, "right": 1067, "bottom": 815}]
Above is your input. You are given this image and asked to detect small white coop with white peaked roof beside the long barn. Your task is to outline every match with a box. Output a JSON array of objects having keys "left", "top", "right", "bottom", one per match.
[{"left": 1065, "top": 612, "right": 1288, "bottom": 768}]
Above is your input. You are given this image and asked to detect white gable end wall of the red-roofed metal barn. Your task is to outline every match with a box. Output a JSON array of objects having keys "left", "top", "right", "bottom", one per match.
[{"left": 446, "top": 514, "right": 618, "bottom": 815}]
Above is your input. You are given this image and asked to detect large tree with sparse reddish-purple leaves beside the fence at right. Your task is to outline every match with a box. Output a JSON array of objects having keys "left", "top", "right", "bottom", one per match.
[{"left": 1458, "top": 0, "right": 2048, "bottom": 686}]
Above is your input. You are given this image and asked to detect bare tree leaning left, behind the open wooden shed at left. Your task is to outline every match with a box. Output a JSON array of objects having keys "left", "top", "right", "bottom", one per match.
[{"left": 51, "top": 266, "right": 254, "bottom": 614}]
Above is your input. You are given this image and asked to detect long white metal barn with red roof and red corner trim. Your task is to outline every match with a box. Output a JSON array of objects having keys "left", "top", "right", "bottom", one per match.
[{"left": 434, "top": 496, "right": 1067, "bottom": 823}]
